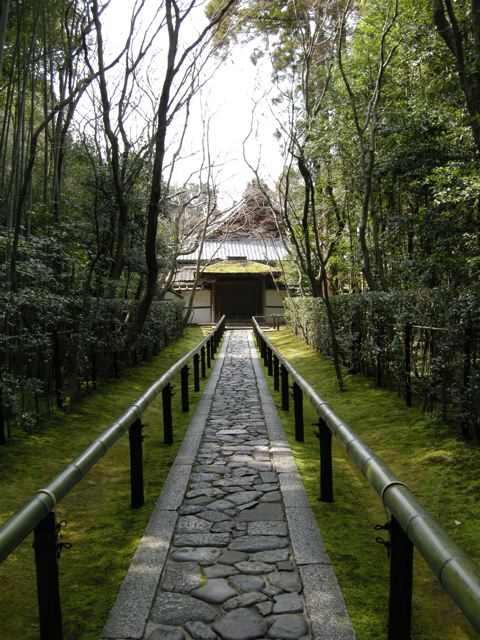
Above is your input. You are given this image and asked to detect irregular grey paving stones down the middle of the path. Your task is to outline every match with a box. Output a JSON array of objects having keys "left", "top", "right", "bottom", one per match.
[{"left": 104, "top": 331, "right": 354, "bottom": 640}]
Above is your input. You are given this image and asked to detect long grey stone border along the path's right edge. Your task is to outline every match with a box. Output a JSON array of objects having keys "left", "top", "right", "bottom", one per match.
[{"left": 248, "top": 333, "right": 356, "bottom": 640}]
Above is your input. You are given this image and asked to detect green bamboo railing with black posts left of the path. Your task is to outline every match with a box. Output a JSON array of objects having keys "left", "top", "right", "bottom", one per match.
[{"left": 0, "top": 316, "right": 225, "bottom": 640}]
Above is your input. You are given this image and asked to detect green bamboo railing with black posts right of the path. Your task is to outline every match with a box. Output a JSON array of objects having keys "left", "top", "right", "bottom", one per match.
[{"left": 253, "top": 318, "right": 480, "bottom": 640}]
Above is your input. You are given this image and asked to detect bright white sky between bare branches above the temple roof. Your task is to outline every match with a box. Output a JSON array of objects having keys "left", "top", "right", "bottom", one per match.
[{"left": 104, "top": 0, "right": 283, "bottom": 206}]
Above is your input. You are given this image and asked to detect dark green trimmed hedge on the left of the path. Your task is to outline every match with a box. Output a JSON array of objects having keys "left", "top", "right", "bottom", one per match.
[{"left": 0, "top": 298, "right": 184, "bottom": 444}]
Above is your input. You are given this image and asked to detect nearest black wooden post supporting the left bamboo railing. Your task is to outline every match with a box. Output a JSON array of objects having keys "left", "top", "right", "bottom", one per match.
[{"left": 33, "top": 511, "right": 63, "bottom": 640}]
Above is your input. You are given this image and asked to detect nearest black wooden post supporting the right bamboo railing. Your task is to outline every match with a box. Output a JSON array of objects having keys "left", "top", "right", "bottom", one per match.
[{"left": 388, "top": 516, "right": 413, "bottom": 640}]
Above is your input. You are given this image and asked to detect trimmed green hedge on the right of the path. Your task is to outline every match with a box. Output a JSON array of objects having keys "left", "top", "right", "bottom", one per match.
[{"left": 286, "top": 288, "right": 480, "bottom": 441}]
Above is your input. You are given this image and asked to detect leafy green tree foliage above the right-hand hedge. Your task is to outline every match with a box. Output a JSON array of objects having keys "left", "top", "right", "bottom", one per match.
[{"left": 217, "top": 0, "right": 479, "bottom": 292}]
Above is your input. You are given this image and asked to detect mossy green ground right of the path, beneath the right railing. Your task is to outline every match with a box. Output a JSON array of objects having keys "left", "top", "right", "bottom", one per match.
[{"left": 262, "top": 328, "right": 480, "bottom": 640}]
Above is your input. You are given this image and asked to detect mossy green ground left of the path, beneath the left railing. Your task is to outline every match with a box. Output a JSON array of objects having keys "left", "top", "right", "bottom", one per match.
[{"left": 0, "top": 328, "right": 212, "bottom": 640}]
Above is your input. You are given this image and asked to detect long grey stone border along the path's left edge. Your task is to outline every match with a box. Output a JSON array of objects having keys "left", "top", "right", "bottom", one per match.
[{"left": 101, "top": 333, "right": 231, "bottom": 640}]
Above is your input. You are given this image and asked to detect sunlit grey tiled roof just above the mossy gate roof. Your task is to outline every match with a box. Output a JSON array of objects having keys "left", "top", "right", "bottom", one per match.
[{"left": 178, "top": 239, "right": 286, "bottom": 263}]
